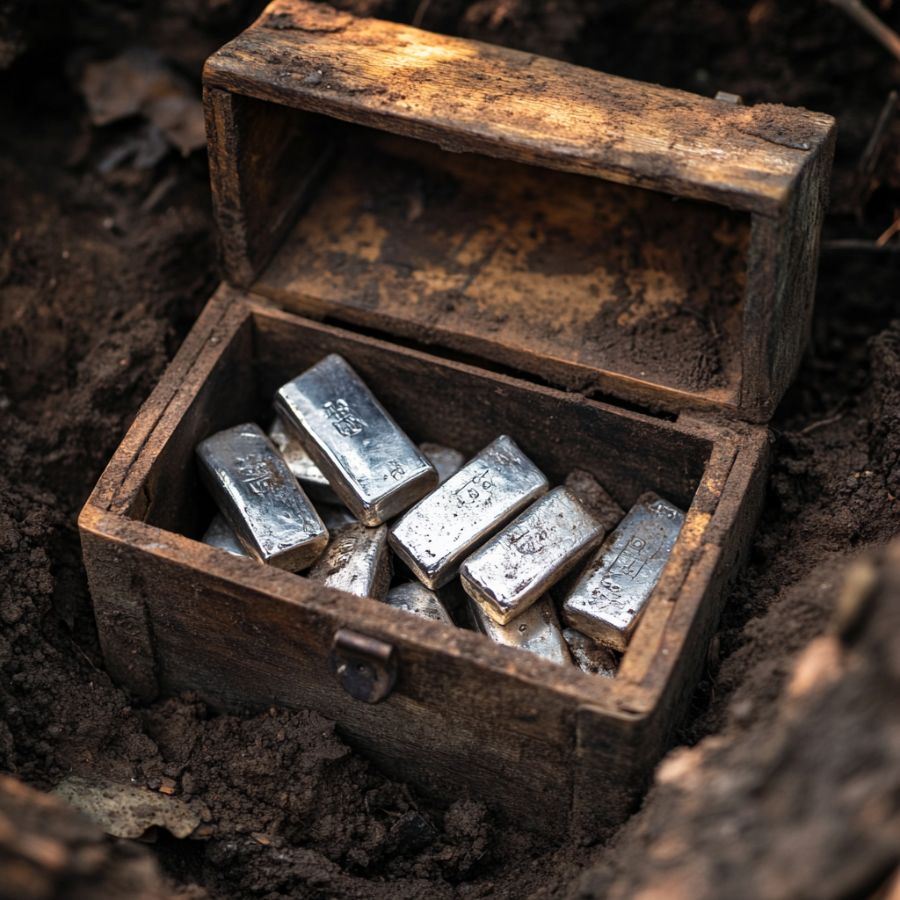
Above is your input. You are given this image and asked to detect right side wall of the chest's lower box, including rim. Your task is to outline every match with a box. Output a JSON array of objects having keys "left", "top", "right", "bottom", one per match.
[{"left": 570, "top": 428, "right": 769, "bottom": 841}]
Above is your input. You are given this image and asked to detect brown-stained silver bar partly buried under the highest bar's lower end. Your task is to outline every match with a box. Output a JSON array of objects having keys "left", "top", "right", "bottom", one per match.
[{"left": 307, "top": 522, "right": 391, "bottom": 600}]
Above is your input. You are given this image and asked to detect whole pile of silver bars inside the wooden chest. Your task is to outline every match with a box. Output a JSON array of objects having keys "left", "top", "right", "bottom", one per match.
[{"left": 197, "top": 354, "right": 684, "bottom": 677}]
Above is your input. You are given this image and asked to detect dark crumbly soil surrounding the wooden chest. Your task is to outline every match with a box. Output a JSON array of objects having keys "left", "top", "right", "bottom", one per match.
[{"left": 0, "top": 0, "right": 900, "bottom": 898}]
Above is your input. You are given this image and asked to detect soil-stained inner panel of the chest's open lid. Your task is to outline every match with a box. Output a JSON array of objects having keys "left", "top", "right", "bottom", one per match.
[{"left": 254, "top": 132, "right": 750, "bottom": 407}]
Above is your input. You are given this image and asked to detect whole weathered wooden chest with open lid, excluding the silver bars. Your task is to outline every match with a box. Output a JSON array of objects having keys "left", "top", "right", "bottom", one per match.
[{"left": 80, "top": 0, "right": 834, "bottom": 837}]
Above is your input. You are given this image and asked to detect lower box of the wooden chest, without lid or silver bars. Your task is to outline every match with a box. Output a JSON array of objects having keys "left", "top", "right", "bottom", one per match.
[{"left": 79, "top": 289, "right": 764, "bottom": 837}]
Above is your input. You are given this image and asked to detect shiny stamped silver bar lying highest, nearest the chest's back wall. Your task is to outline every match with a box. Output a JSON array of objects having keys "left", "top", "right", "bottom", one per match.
[{"left": 275, "top": 353, "right": 437, "bottom": 525}]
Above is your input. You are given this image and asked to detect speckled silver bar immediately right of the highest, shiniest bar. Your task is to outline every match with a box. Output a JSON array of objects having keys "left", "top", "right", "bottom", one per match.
[{"left": 389, "top": 434, "right": 547, "bottom": 589}]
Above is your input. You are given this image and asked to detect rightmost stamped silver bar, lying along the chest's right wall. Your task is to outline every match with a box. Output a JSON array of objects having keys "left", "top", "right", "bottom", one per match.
[{"left": 562, "top": 494, "right": 684, "bottom": 651}]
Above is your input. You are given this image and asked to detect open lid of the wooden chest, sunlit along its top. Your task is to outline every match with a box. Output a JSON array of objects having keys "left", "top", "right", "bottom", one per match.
[{"left": 204, "top": 0, "right": 834, "bottom": 422}]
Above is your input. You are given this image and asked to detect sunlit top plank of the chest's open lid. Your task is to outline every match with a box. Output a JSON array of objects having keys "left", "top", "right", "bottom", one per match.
[{"left": 204, "top": 0, "right": 833, "bottom": 215}]
